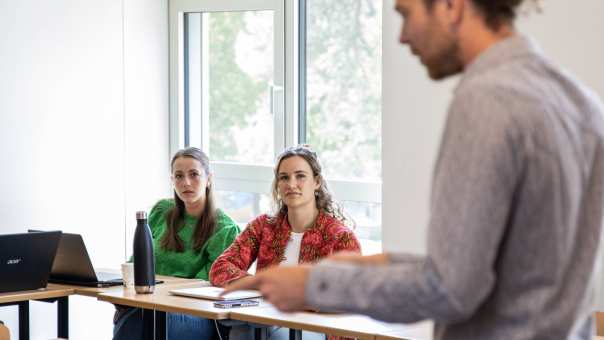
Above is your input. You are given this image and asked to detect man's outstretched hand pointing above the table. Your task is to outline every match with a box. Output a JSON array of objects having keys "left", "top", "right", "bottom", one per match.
[{"left": 222, "top": 266, "right": 310, "bottom": 312}]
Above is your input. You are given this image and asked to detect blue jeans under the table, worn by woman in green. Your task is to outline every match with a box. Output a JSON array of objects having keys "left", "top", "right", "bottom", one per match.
[{"left": 113, "top": 308, "right": 216, "bottom": 340}]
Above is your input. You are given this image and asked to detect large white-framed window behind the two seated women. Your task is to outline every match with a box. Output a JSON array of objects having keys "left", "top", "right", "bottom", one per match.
[{"left": 170, "top": 0, "right": 382, "bottom": 250}]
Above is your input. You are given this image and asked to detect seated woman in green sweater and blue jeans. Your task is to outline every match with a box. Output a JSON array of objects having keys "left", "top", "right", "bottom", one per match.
[{"left": 113, "top": 148, "right": 240, "bottom": 340}]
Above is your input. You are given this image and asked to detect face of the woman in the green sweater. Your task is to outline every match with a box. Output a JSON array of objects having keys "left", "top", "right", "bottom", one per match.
[{"left": 172, "top": 157, "right": 210, "bottom": 206}]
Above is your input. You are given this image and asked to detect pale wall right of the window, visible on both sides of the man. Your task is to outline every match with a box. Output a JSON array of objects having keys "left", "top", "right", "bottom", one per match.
[{"left": 382, "top": 0, "right": 604, "bottom": 300}]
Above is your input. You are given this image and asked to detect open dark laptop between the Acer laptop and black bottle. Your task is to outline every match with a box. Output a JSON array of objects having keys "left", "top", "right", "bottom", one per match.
[{"left": 29, "top": 230, "right": 123, "bottom": 287}]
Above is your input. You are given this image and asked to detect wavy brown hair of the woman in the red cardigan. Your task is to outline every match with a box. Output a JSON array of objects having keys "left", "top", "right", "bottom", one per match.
[{"left": 272, "top": 145, "right": 354, "bottom": 227}]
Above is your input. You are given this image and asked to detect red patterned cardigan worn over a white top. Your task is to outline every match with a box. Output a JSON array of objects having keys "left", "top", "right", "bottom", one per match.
[{"left": 210, "top": 212, "right": 361, "bottom": 287}]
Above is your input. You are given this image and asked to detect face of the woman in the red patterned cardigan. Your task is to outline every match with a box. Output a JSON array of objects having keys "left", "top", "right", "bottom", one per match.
[{"left": 277, "top": 156, "right": 320, "bottom": 210}]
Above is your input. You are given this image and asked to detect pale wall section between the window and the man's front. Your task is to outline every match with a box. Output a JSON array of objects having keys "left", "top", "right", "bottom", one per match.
[{"left": 382, "top": 0, "right": 455, "bottom": 253}]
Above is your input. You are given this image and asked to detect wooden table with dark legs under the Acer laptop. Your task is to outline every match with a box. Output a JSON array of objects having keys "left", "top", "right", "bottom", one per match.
[{"left": 0, "top": 283, "right": 74, "bottom": 340}]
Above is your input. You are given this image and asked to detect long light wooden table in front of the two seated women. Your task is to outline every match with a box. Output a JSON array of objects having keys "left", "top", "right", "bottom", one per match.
[{"left": 97, "top": 280, "right": 432, "bottom": 340}]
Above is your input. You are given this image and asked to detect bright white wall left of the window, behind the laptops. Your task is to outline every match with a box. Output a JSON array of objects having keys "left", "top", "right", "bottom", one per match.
[{"left": 0, "top": 0, "right": 169, "bottom": 339}]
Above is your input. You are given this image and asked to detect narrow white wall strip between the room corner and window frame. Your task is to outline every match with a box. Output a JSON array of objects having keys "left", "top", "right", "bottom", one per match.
[{"left": 124, "top": 0, "right": 172, "bottom": 257}]
